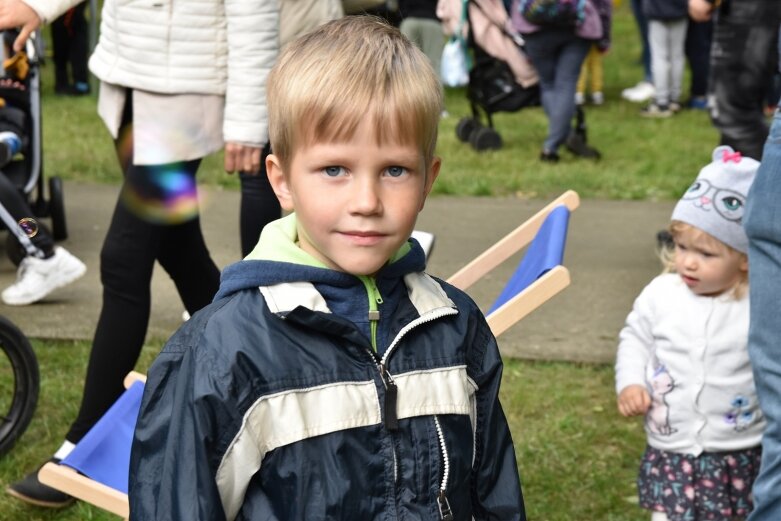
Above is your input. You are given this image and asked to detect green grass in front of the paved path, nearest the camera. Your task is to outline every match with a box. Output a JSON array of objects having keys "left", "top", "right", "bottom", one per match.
[{"left": 0, "top": 341, "right": 648, "bottom": 521}]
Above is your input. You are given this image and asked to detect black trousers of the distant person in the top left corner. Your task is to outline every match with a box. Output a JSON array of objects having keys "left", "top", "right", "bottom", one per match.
[{"left": 51, "top": 2, "right": 89, "bottom": 88}]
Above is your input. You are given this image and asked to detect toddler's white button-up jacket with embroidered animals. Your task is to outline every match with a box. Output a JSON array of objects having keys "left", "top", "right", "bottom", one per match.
[{"left": 616, "top": 274, "right": 765, "bottom": 455}]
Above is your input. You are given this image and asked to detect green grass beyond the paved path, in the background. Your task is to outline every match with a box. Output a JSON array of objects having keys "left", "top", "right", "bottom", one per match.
[{"left": 43, "top": 7, "right": 718, "bottom": 199}]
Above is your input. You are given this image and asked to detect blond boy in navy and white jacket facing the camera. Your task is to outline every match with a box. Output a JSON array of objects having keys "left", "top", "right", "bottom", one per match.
[{"left": 130, "top": 16, "right": 525, "bottom": 521}]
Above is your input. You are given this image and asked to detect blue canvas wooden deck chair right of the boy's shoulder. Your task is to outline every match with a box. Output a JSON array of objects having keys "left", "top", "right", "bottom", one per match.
[{"left": 448, "top": 190, "right": 580, "bottom": 336}]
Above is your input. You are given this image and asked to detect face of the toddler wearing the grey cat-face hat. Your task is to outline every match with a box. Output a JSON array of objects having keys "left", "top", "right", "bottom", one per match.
[{"left": 674, "top": 227, "right": 748, "bottom": 296}]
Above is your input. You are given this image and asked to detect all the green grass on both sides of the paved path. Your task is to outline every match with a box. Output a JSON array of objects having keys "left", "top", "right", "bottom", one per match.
[{"left": 0, "top": 2, "right": 732, "bottom": 521}]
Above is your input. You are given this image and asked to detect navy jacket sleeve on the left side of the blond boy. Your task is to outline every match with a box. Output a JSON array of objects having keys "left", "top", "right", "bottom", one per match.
[{"left": 129, "top": 336, "right": 233, "bottom": 521}]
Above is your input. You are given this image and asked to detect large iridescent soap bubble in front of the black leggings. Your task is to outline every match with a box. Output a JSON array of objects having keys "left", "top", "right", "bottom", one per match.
[{"left": 121, "top": 164, "right": 198, "bottom": 224}]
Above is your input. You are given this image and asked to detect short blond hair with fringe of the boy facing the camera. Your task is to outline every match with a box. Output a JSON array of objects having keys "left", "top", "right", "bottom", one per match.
[{"left": 267, "top": 16, "right": 442, "bottom": 168}]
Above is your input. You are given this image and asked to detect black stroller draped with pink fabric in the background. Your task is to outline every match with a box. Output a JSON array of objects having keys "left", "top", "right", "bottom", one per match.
[{"left": 437, "top": 0, "right": 540, "bottom": 151}]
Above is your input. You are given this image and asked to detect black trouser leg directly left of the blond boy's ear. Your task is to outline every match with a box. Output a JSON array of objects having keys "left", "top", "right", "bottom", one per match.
[{"left": 239, "top": 145, "right": 282, "bottom": 257}]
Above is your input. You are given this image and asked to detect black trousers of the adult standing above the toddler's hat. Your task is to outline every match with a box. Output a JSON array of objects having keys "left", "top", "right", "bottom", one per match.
[{"left": 709, "top": 0, "right": 781, "bottom": 159}]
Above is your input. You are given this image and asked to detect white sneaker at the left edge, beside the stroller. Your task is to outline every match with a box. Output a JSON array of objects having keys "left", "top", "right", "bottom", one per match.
[{"left": 2, "top": 246, "right": 87, "bottom": 306}]
